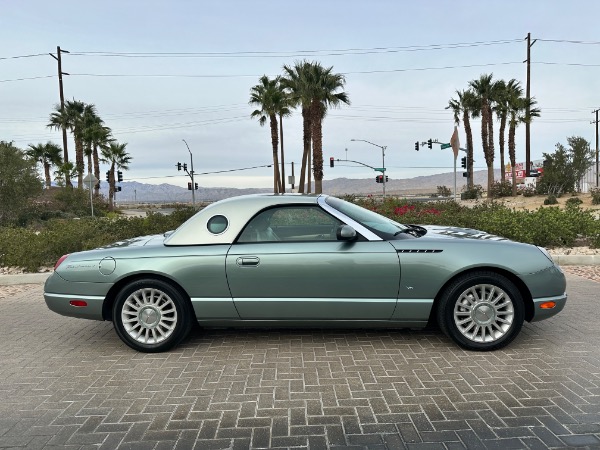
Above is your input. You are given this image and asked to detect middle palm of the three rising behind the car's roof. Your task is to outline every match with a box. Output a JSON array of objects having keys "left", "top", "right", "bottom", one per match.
[{"left": 281, "top": 60, "right": 312, "bottom": 194}]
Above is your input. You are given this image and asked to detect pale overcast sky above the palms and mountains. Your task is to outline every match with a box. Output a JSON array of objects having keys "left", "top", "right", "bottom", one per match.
[{"left": 0, "top": 0, "right": 600, "bottom": 187}]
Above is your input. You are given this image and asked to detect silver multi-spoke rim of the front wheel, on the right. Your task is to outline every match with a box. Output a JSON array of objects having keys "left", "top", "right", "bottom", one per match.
[{"left": 454, "top": 284, "right": 515, "bottom": 343}]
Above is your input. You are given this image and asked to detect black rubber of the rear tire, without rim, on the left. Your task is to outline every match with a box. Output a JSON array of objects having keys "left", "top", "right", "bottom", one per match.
[{"left": 112, "top": 278, "right": 192, "bottom": 353}]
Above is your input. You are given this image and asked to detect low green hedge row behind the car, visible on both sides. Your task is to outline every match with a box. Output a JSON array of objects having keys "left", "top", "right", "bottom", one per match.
[{"left": 0, "top": 198, "right": 600, "bottom": 271}]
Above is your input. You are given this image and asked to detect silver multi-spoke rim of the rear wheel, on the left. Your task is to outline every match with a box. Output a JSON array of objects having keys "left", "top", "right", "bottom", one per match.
[{"left": 121, "top": 288, "right": 177, "bottom": 344}]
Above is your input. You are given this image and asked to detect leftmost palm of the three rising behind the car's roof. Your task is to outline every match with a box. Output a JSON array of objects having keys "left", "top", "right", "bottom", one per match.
[{"left": 248, "top": 75, "right": 287, "bottom": 194}]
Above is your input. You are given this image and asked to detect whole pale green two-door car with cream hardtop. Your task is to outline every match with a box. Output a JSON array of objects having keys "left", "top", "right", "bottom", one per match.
[{"left": 44, "top": 194, "right": 567, "bottom": 352}]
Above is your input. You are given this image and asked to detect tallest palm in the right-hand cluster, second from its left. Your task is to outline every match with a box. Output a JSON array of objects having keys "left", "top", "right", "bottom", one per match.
[{"left": 469, "top": 74, "right": 500, "bottom": 198}]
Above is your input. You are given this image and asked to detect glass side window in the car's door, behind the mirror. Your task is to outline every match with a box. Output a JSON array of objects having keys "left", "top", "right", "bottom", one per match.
[{"left": 238, "top": 206, "right": 342, "bottom": 242}]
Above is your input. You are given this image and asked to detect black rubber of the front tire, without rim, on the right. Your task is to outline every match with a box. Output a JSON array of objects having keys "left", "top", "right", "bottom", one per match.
[{"left": 438, "top": 272, "right": 525, "bottom": 351}]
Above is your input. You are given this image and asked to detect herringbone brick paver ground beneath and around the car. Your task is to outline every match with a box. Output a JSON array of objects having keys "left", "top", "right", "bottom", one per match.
[{"left": 0, "top": 275, "right": 600, "bottom": 449}]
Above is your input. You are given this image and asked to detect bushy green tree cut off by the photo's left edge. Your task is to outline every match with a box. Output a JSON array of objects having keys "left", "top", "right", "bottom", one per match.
[{"left": 0, "top": 141, "right": 42, "bottom": 225}]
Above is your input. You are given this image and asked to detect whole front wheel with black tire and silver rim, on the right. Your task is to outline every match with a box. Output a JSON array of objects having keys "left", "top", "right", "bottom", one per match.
[{"left": 437, "top": 271, "right": 525, "bottom": 351}]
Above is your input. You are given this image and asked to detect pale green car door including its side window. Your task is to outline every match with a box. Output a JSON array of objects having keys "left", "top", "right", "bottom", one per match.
[{"left": 226, "top": 205, "right": 400, "bottom": 320}]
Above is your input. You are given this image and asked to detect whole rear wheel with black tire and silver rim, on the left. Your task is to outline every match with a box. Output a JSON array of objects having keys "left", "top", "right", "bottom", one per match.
[{"left": 112, "top": 278, "right": 194, "bottom": 353}]
